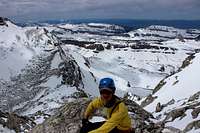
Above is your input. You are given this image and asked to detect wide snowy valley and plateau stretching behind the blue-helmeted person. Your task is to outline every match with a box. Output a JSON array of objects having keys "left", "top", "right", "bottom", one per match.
[{"left": 46, "top": 24, "right": 200, "bottom": 97}]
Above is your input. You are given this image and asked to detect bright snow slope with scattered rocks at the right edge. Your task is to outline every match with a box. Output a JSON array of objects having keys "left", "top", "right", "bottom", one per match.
[{"left": 145, "top": 53, "right": 200, "bottom": 133}]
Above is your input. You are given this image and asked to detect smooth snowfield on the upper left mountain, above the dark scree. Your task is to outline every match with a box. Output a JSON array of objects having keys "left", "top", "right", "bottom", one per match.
[{"left": 0, "top": 21, "right": 54, "bottom": 80}]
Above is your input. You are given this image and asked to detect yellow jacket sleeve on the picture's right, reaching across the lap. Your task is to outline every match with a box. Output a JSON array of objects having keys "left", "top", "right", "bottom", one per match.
[{"left": 89, "top": 103, "right": 127, "bottom": 133}]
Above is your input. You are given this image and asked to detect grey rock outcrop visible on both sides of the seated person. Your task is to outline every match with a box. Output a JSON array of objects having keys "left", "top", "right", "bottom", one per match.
[{"left": 31, "top": 98, "right": 163, "bottom": 133}]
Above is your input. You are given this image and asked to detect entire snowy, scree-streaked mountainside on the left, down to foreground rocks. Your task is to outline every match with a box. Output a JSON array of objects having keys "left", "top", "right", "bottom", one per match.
[{"left": 0, "top": 20, "right": 82, "bottom": 121}]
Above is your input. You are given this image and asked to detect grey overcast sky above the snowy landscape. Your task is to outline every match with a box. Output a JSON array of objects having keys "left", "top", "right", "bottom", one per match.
[{"left": 0, "top": 0, "right": 200, "bottom": 21}]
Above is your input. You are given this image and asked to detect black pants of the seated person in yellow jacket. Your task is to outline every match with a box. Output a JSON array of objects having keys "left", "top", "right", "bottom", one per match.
[{"left": 80, "top": 122, "right": 119, "bottom": 133}]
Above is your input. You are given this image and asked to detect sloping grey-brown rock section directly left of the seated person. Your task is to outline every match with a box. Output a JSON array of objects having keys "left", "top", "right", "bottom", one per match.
[{"left": 31, "top": 99, "right": 91, "bottom": 133}]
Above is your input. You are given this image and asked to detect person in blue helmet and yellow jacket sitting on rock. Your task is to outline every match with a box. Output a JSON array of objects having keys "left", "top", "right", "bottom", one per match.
[{"left": 80, "top": 78, "right": 131, "bottom": 133}]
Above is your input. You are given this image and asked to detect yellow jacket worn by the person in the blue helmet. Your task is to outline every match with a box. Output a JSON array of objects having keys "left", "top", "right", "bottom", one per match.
[{"left": 85, "top": 97, "right": 131, "bottom": 133}]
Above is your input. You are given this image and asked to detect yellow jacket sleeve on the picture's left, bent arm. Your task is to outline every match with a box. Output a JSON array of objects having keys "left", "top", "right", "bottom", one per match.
[{"left": 84, "top": 97, "right": 104, "bottom": 118}]
